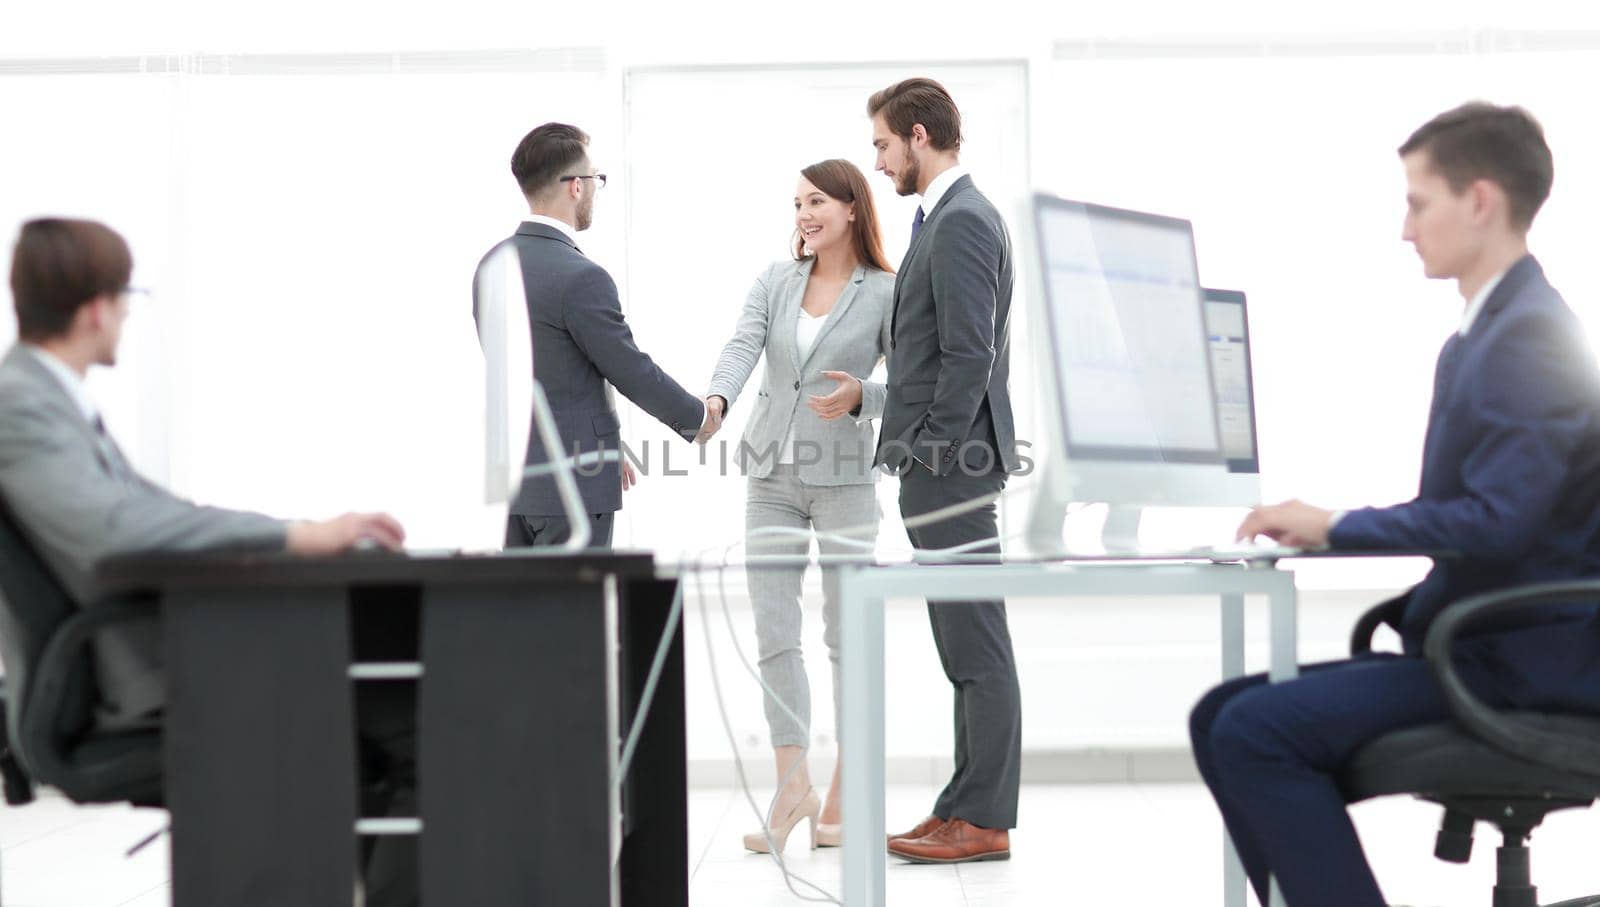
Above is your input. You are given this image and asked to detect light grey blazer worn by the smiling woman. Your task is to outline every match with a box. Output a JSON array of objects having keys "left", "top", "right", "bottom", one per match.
[{"left": 707, "top": 259, "right": 894, "bottom": 485}]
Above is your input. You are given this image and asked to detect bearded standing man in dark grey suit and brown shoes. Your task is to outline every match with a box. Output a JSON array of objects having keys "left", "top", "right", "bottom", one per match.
[{"left": 867, "top": 78, "right": 1022, "bottom": 862}]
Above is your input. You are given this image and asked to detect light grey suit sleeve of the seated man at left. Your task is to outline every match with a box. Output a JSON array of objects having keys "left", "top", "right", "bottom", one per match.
[{"left": 0, "top": 405, "right": 288, "bottom": 600}]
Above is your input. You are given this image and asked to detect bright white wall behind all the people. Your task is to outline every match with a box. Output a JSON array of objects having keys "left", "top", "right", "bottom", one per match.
[{"left": 0, "top": 0, "right": 1600, "bottom": 750}]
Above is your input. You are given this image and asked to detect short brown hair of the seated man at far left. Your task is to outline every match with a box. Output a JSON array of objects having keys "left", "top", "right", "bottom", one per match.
[{"left": 11, "top": 218, "right": 133, "bottom": 341}]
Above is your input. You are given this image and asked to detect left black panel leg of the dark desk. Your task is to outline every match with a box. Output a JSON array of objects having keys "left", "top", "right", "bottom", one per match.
[{"left": 162, "top": 587, "right": 357, "bottom": 907}]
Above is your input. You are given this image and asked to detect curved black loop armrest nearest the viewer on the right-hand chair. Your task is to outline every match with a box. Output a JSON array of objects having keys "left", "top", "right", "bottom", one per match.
[{"left": 1422, "top": 579, "right": 1600, "bottom": 776}]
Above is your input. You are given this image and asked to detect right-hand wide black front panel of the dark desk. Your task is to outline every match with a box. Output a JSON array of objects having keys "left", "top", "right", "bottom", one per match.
[{"left": 418, "top": 579, "right": 616, "bottom": 907}]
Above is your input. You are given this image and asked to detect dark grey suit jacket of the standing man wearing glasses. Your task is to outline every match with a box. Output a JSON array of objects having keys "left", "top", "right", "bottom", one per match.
[{"left": 472, "top": 222, "right": 706, "bottom": 517}]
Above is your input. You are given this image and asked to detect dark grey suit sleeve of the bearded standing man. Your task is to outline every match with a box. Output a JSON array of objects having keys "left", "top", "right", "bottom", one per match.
[{"left": 912, "top": 208, "right": 1002, "bottom": 475}]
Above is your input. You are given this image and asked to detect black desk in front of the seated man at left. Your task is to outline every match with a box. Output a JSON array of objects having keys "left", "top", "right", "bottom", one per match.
[{"left": 101, "top": 552, "right": 688, "bottom": 907}]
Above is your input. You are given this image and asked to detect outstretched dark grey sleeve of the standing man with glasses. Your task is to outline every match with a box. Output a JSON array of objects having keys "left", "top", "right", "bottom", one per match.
[{"left": 562, "top": 267, "right": 706, "bottom": 440}]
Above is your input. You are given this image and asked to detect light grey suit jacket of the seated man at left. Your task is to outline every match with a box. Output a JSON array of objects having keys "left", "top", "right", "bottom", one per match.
[{"left": 0, "top": 346, "right": 286, "bottom": 728}]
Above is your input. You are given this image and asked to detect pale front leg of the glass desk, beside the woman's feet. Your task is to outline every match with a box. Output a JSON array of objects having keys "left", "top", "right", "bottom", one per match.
[{"left": 838, "top": 568, "right": 888, "bottom": 907}]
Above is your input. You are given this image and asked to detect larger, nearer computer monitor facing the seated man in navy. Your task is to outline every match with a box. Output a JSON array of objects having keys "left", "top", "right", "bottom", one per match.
[{"left": 1022, "top": 194, "right": 1254, "bottom": 552}]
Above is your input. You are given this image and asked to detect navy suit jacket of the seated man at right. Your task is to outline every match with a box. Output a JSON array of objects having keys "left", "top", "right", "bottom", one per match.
[{"left": 1330, "top": 256, "right": 1600, "bottom": 667}]
